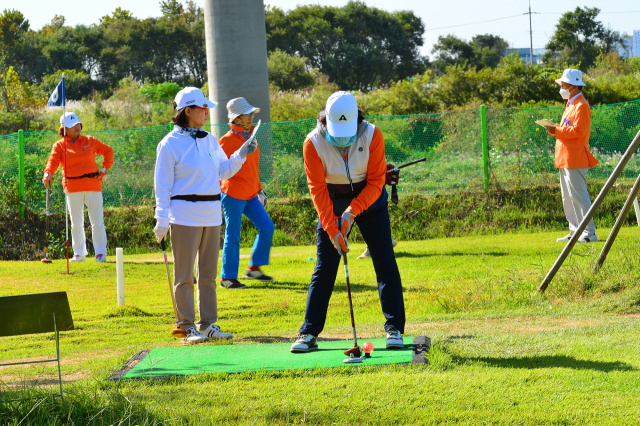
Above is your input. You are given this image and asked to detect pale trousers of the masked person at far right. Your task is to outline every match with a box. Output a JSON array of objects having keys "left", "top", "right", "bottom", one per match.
[{"left": 559, "top": 169, "right": 596, "bottom": 238}]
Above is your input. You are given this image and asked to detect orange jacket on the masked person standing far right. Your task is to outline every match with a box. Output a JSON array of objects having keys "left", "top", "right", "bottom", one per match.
[{"left": 554, "top": 94, "right": 598, "bottom": 169}]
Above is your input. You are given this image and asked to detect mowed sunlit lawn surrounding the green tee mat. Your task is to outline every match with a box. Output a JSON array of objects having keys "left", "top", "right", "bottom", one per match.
[{"left": 0, "top": 227, "right": 640, "bottom": 425}]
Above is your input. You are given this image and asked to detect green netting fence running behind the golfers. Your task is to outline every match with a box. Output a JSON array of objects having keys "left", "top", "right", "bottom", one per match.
[{"left": 0, "top": 101, "right": 640, "bottom": 216}]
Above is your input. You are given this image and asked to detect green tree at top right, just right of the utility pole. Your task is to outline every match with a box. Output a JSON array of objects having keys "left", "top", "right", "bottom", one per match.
[{"left": 544, "top": 7, "right": 622, "bottom": 70}]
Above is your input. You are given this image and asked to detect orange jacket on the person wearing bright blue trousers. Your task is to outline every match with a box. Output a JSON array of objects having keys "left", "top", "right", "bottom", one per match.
[{"left": 218, "top": 124, "right": 262, "bottom": 200}]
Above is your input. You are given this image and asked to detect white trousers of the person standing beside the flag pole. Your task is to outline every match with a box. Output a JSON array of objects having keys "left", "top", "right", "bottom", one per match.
[{"left": 67, "top": 191, "right": 107, "bottom": 256}]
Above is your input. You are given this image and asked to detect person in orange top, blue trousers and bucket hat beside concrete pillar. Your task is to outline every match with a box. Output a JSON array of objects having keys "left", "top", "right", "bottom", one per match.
[{"left": 220, "top": 98, "right": 275, "bottom": 289}]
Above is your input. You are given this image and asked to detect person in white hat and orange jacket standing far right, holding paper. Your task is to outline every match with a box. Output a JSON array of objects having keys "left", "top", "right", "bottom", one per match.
[{"left": 545, "top": 68, "right": 598, "bottom": 243}]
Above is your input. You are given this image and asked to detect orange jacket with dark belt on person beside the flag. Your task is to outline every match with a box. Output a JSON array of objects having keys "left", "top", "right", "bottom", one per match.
[{"left": 44, "top": 135, "right": 113, "bottom": 192}]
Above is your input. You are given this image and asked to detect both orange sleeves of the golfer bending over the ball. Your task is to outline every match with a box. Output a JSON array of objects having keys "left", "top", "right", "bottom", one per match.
[{"left": 302, "top": 127, "right": 387, "bottom": 235}]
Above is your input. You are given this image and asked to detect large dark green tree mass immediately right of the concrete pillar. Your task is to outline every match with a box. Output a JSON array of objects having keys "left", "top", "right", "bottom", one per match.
[{"left": 265, "top": 1, "right": 426, "bottom": 90}]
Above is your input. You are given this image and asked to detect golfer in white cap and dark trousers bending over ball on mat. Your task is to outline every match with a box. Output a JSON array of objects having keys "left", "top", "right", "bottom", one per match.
[{"left": 290, "top": 91, "right": 405, "bottom": 353}]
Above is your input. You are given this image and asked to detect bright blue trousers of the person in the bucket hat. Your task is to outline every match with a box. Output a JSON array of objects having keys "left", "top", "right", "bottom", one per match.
[{"left": 220, "top": 192, "right": 275, "bottom": 280}]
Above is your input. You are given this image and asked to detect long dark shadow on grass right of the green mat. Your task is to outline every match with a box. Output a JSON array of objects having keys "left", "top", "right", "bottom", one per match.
[{"left": 458, "top": 355, "right": 636, "bottom": 372}]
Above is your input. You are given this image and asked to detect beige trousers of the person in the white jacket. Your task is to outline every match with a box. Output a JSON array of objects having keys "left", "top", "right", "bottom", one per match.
[{"left": 171, "top": 224, "right": 220, "bottom": 330}]
